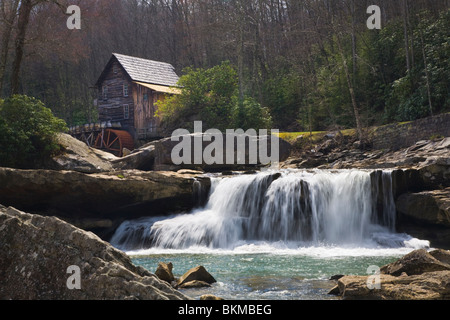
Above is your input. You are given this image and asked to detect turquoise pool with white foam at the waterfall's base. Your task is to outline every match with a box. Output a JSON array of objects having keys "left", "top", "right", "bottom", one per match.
[{"left": 130, "top": 247, "right": 406, "bottom": 300}]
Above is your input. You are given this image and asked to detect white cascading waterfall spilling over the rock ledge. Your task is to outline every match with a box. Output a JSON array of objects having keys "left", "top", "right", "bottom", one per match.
[{"left": 111, "top": 170, "right": 408, "bottom": 249}]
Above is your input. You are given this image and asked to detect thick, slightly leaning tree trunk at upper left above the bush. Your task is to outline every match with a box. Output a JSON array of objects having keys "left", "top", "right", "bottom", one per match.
[{"left": 11, "top": 0, "right": 33, "bottom": 94}]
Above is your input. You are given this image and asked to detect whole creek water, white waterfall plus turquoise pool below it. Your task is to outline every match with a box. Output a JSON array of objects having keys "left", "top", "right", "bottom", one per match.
[{"left": 111, "top": 170, "right": 429, "bottom": 300}]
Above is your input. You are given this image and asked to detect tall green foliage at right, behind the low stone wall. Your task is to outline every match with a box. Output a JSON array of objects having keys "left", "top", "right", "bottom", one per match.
[{"left": 299, "top": 10, "right": 450, "bottom": 130}]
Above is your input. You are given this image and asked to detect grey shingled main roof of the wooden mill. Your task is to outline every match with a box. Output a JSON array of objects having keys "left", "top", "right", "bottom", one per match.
[{"left": 97, "top": 53, "right": 179, "bottom": 87}]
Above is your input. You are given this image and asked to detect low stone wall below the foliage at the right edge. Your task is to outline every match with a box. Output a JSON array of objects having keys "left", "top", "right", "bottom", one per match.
[{"left": 371, "top": 113, "right": 450, "bottom": 151}]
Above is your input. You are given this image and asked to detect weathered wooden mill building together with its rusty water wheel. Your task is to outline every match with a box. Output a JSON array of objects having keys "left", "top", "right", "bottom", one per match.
[{"left": 70, "top": 53, "right": 181, "bottom": 156}]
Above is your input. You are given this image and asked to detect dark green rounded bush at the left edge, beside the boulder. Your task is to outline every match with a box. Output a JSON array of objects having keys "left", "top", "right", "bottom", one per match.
[{"left": 0, "top": 95, "right": 67, "bottom": 168}]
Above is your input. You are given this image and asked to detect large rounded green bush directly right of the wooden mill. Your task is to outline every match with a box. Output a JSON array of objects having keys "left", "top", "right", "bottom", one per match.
[{"left": 157, "top": 62, "right": 271, "bottom": 134}]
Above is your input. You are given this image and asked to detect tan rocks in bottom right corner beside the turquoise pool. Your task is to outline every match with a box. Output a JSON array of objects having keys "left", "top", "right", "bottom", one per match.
[{"left": 330, "top": 249, "right": 450, "bottom": 300}]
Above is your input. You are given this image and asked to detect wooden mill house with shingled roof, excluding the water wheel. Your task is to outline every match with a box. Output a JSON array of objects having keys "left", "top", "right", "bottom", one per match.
[{"left": 95, "top": 53, "right": 179, "bottom": 140}]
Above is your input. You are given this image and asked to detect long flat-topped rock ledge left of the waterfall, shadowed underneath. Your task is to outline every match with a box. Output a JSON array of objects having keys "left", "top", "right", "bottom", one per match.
[{"left": 0, "top": 168, "right": 202, "bottom": 237}]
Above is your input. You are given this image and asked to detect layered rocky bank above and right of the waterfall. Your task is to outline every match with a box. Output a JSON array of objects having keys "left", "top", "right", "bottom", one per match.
[{"left": 282, "top": 135, "right": 450, "bottom": 249}]
